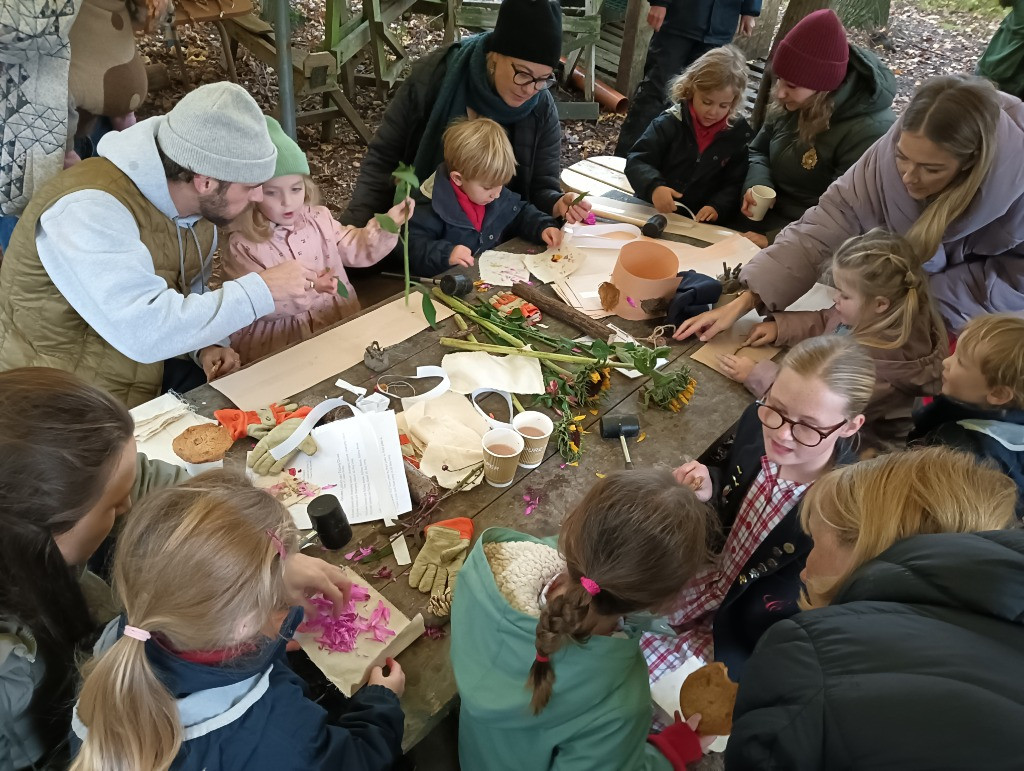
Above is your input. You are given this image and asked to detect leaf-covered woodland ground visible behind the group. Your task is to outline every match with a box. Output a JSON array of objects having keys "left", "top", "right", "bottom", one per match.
[{"left": 139, "top": 0, "right": 1000, "bottom": 217}]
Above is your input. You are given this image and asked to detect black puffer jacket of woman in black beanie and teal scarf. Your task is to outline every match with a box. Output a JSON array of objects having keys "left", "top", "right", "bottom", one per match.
[{"left": 340, "top": 43, "right": 562, "bottom": 227}]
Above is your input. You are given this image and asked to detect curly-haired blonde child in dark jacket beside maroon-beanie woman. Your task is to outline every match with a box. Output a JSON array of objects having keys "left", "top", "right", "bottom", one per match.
[{"left": 626, "top": 45, "right": 754, "bottom": 222}]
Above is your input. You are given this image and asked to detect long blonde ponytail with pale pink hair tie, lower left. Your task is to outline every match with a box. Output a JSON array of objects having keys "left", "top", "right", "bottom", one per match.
[{"left": 71, "top": 471, "right": 298, "bottom": 771}]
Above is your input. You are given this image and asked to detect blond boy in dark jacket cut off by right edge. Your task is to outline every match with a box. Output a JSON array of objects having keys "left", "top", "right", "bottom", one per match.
[{"left": 909, "top": 313, "right": 1024, "bottom": 520}]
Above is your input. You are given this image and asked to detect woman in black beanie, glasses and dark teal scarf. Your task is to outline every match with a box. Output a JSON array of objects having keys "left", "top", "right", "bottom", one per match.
[{"left": 341, "top": 0, "right": 590, "bottom": 243}]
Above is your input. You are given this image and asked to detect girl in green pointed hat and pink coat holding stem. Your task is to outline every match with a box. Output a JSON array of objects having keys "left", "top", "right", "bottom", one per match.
[{"left": 222, "top": 118, "right": 413, "bottom": 365}]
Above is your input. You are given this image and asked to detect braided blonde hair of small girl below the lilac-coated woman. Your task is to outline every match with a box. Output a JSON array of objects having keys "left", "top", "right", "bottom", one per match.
[{"left": 829, "top": 227, "right": 945, "bottom": 349}]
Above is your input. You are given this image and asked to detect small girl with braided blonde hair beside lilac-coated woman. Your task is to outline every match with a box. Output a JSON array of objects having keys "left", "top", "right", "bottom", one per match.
[{"left": 720, "top": 228, "right": 947, "bottom": 436}]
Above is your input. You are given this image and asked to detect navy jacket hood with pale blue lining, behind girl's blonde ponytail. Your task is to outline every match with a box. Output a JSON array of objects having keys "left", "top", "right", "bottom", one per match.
[{"left": 72, "top": 608, "right": 302, "bottom": 741}]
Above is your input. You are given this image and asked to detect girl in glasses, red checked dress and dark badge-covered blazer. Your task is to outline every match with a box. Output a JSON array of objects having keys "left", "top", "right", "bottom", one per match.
[{"left": 640, "top": 335, "right": 874, "bottom": 682}]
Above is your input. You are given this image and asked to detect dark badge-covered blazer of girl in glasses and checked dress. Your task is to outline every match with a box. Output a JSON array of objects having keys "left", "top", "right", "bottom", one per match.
[{"left": 709, "top": 404, "right": 856, "bottom": 682}]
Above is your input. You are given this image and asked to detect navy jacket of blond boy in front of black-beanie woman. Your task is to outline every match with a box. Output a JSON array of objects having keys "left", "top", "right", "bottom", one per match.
[{"left": 409, "top": 164, "right": 558, "bottom": 275}]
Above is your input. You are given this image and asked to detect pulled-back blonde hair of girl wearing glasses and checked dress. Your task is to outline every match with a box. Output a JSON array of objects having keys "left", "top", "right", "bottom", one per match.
[{"left": 781, "top": 335, "right": 874, "bottom": 419}]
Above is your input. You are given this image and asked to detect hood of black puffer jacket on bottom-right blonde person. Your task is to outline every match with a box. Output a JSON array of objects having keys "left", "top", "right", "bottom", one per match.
[{"left": 833, "top": 529, "right": 1024, "bottom": 625}]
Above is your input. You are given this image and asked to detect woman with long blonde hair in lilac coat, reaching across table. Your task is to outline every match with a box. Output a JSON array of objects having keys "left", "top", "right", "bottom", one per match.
[{"left": 676, "top": 75, "right": 1024, "bottom": 340}]
